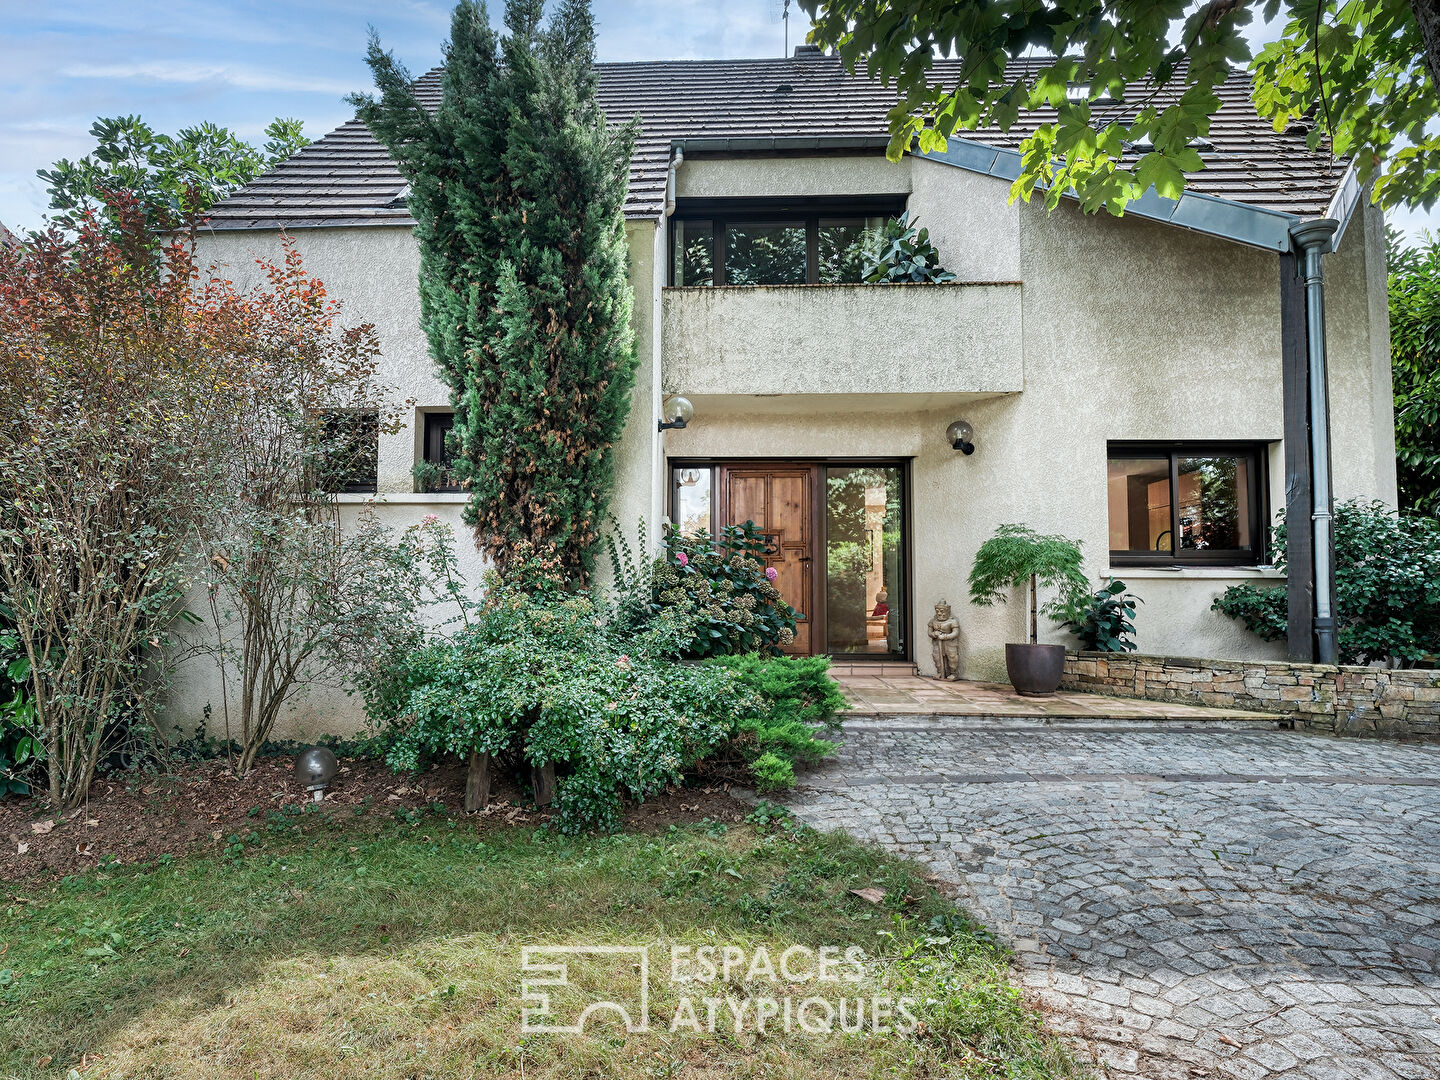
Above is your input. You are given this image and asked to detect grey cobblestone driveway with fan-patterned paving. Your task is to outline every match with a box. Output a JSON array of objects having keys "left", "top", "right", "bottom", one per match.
[{"left": 789, "top": 716, "right": 1440, "bottom": 1080}]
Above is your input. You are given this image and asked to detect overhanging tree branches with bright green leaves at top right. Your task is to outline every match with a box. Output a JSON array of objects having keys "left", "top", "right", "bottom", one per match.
[{"left": 801, "top": 0, "right": 1440, "bottom": 215}]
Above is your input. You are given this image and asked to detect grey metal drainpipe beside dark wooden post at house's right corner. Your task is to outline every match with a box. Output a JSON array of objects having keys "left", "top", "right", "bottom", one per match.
[{"left": 1290, "top": 217, "right": 1339, "bottom": 664}]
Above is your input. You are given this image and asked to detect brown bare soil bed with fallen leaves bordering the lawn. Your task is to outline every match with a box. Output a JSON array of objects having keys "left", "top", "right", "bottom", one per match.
[{"left": 0, "top": 756, "right": 747, "bottom": 881}]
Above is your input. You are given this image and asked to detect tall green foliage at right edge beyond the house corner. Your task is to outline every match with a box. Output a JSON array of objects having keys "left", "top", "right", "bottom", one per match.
[{"left": 1387, "top": 230, "right": 1440, "bottom": 517}]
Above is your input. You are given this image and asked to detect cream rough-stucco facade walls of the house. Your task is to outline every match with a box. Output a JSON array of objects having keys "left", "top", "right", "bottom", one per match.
[{"left": 183, "top": 146, "right": 1395, "bottom": 734}]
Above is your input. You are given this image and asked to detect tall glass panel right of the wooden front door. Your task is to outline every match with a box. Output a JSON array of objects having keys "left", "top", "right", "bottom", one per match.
[{"left": 824, "top": 465, "right": 909, "bottom": 660}]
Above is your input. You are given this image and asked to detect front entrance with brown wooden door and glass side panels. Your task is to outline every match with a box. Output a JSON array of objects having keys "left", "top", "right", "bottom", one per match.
[{"left": 670, "top": 461, "right": 910, "bottom": 660}]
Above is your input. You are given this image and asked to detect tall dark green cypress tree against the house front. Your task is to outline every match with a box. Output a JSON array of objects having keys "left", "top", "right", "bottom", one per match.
[{"left": 351, "top": 0, "right": 636, "bottom": 585}]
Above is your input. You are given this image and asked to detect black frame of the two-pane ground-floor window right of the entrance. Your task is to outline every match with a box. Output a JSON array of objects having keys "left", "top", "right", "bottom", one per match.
[{"left": 1104, "top": 441, "right": 1270, "bottom": 567}]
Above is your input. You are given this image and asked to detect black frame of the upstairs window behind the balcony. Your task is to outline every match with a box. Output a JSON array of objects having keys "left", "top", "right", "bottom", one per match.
[{"left": 665, "top": 194, "right": 909, "bottom": 288}]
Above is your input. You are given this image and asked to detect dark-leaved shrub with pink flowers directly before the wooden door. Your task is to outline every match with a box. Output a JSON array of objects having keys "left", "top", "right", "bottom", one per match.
[{"left": 649, "top": 521, "right": 796, "bottom": 657}]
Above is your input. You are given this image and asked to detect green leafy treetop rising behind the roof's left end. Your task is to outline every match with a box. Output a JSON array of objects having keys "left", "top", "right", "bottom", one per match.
[{"left": 36, "top": 117, "right": 310, "bottom": 232}]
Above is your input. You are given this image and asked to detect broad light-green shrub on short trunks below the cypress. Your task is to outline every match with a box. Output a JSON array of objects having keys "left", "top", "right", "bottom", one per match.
[{"left": 367, "top": 576, "right": 760, "bottom": 832}]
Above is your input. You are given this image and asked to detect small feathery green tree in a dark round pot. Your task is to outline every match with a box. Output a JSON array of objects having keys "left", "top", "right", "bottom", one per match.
[{"left": 971, "top": 526, "right": 1090, "bottom": 697}]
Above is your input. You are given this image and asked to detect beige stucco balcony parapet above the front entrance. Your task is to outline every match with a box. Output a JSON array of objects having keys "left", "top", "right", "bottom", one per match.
[{"left": 661, "top": 282, "right": 1024, "bottom": 408}]
